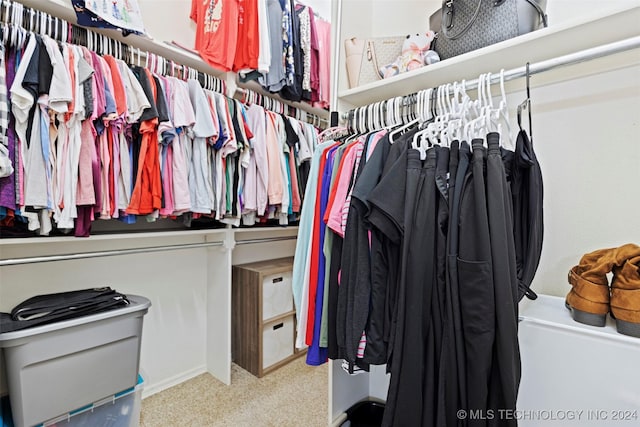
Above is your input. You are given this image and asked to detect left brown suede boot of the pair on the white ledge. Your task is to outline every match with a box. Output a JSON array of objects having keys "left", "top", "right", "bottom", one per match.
[{"left": 565, "top": 244, "right": 640, "bottom": 326}]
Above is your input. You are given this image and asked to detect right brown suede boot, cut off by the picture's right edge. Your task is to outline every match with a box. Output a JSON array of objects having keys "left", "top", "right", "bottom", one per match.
[{"left": 611, "top": 255, "right": 640, "bottom": 338}]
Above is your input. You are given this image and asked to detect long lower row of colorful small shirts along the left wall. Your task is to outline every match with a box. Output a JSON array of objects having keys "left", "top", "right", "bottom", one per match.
[{"left": 0, "top": 15, "right": 318, "bottom": 237}]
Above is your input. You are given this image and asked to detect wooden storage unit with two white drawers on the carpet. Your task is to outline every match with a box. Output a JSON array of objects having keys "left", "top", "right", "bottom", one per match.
[{"left": 232, "top": 258, "right": 303, "bottom": 377}]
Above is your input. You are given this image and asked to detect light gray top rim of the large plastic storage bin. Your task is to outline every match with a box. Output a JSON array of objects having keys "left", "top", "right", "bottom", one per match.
[{"left": 0, "top": 295, "right": 151, "bottom": 348}]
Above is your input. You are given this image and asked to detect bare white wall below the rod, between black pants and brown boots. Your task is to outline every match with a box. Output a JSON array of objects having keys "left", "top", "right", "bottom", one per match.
[{"left": 510, "top": 61, "right": 640, "bottom": 296}]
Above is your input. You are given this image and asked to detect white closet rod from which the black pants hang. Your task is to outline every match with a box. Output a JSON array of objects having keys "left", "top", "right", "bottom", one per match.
[{"left": 342, "top": 36, "right": 640, "bottom": 120}]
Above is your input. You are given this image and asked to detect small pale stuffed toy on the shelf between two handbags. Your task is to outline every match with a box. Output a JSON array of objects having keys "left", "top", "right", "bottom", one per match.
[{"left": 379, "top": 31, "right": 439, "bottom": 79}]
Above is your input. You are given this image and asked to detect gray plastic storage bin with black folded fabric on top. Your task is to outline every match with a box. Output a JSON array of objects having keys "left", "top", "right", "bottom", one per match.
[{"left": 0, "top": 295, "right": 151, "bottom": 427}]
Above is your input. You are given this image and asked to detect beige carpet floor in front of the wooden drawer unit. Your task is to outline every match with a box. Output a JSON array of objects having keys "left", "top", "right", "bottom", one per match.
[{"left": 140, "top": 356, "right": 328, "bottom": 427}]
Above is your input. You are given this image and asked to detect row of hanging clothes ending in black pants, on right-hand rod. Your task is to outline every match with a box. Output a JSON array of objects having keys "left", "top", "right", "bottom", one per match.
[{"left": 293, "top": 105, "right": 542, "bottom": 426}]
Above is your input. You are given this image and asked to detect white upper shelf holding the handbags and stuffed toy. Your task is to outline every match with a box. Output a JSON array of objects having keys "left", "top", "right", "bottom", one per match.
[{"left": 338, "top": 6, "right": 640, "bottom": 108}]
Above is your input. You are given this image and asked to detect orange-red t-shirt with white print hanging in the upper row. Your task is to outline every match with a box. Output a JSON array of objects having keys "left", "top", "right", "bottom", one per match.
[{"left": 189, "top": 0, "right": 239, "bottom": 71}]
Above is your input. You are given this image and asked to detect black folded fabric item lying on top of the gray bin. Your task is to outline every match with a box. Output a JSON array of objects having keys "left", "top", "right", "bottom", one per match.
[{"left": 0, "top": 287, "right": 129, "bottom": 333}]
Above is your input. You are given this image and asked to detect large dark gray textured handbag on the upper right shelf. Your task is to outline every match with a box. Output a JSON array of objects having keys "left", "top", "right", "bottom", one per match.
[{"left": 429, "top": 0, "right": 547, "bottom": 60}]
